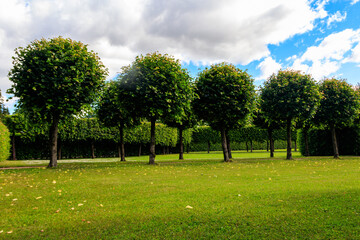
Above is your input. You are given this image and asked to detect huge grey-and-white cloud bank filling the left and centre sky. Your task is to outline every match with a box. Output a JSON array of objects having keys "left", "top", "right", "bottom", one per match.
[{"left": 0, "top": 0, "right": 327, "bottom": 99}]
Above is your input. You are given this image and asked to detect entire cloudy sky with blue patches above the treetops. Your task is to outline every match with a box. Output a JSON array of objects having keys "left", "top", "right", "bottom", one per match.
[{"left": 0, "top": 0, "right": 360, "bottom": 110}]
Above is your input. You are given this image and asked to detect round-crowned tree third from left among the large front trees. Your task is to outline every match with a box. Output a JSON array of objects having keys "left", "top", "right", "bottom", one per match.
[{"left": 193, "top": 63, "right": 254, "bottom": 162}]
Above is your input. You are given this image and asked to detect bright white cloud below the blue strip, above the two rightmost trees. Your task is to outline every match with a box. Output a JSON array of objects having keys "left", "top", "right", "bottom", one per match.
[{"left": 292, "top": 29, "right": 360, "bottom": 80}]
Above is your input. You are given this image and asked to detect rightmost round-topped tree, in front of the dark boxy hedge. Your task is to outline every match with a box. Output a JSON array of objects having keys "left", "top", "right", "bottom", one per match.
[{"left": 315, "top": 78, "right": 360, "bottom": 158}]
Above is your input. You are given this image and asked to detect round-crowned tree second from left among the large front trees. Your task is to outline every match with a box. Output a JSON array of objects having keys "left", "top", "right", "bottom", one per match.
[{"left": 123, "top": 52, "right": 191, "bottom": 164}]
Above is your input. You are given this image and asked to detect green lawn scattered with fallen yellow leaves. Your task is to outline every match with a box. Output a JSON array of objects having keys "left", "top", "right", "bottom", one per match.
[{"left": 0, "top": 152, "right": 360, "bottom": 239}]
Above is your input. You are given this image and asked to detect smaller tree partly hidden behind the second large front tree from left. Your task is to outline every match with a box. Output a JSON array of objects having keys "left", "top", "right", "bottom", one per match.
[{"left": 97, "top": 78, "right": 140, "bottom": 161}]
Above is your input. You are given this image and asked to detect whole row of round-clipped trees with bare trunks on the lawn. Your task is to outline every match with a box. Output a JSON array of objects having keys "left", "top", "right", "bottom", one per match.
[{"left": 8, "top": 37, "right": 359, "bottom": 167}]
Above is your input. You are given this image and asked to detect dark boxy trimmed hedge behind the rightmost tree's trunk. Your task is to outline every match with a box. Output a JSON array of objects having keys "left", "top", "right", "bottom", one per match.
[{"left": 299, "top": 126, "right": 360, "bottom": 156}]
